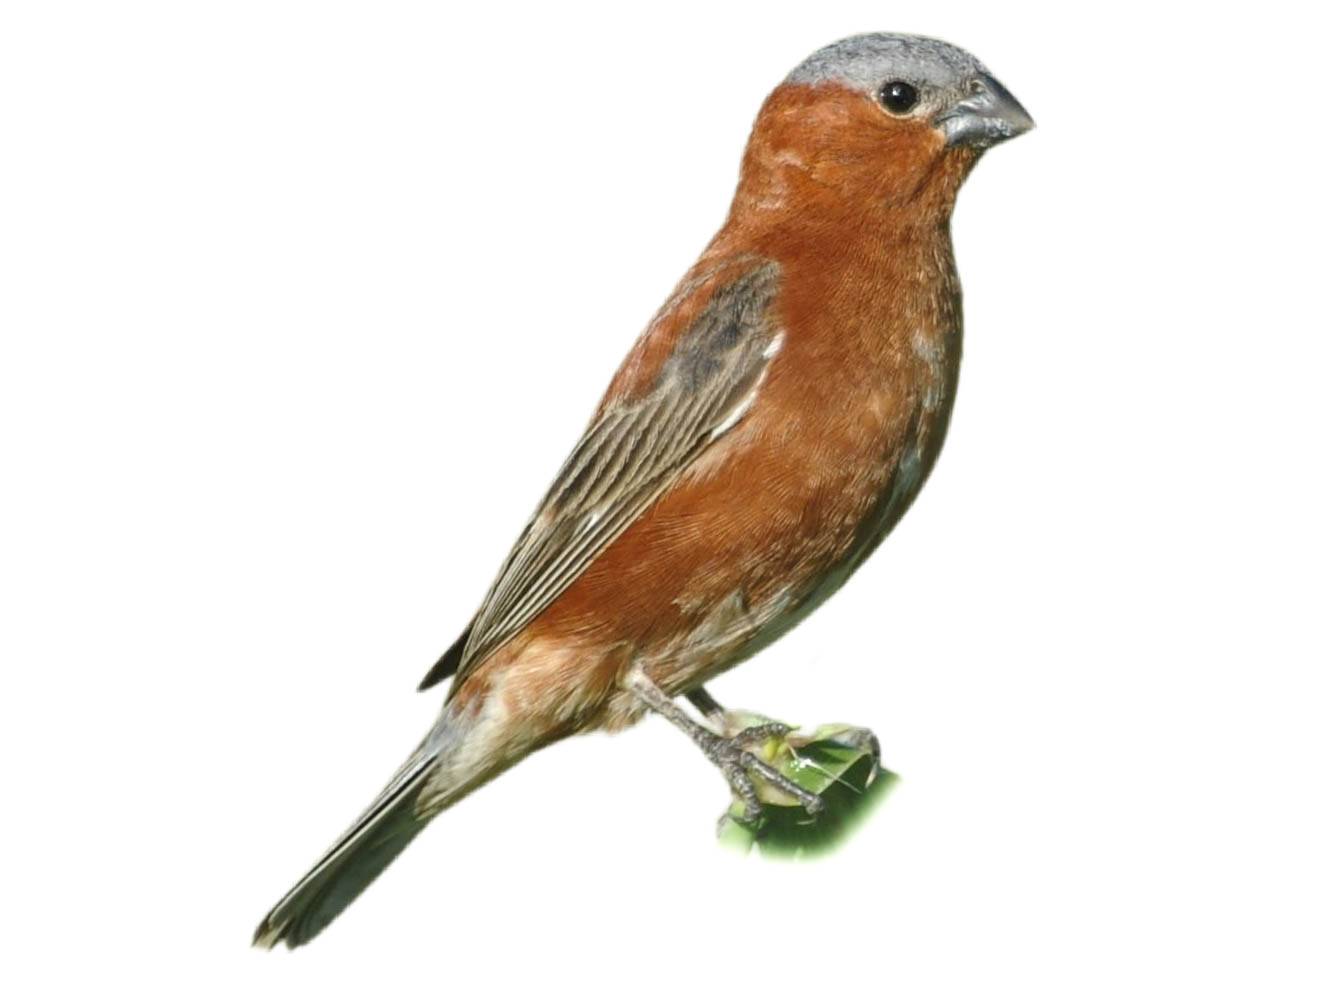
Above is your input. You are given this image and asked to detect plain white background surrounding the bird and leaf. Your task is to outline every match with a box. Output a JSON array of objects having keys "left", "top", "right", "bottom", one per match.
[{"left": 0, "top": 0, "right": 1318, "bottom": 986}]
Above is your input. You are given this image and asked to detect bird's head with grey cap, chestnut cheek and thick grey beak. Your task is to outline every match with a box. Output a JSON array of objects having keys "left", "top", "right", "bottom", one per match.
[{"left": 742, "top": 34, "right": 1035, "bottom": 216}]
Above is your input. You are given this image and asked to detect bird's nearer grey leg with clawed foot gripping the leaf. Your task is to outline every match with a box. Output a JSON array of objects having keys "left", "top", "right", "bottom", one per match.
[{"left": 626, "top": 669, "right": 824, "bottom": 822}]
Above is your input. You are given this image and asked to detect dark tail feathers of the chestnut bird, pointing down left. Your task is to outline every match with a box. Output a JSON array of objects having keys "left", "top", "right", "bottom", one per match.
[{"left": 252, "top": 750, "right": 436, "bottom": 948}]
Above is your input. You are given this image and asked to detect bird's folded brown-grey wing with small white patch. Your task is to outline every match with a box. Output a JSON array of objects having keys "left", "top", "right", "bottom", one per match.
[{"left": 422, "top": 262, "right": 782, "bottom": 690}]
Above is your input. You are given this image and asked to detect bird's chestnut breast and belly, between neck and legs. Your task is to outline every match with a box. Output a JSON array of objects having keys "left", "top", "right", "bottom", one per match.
[{"left": 529, "top": 218, "right": 961, "bottom": 690}]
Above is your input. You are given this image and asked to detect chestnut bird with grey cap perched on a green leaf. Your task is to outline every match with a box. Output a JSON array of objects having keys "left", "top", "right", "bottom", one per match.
[{"left": 254, "top": 33, "right": 1033, "bottom": 948}]
